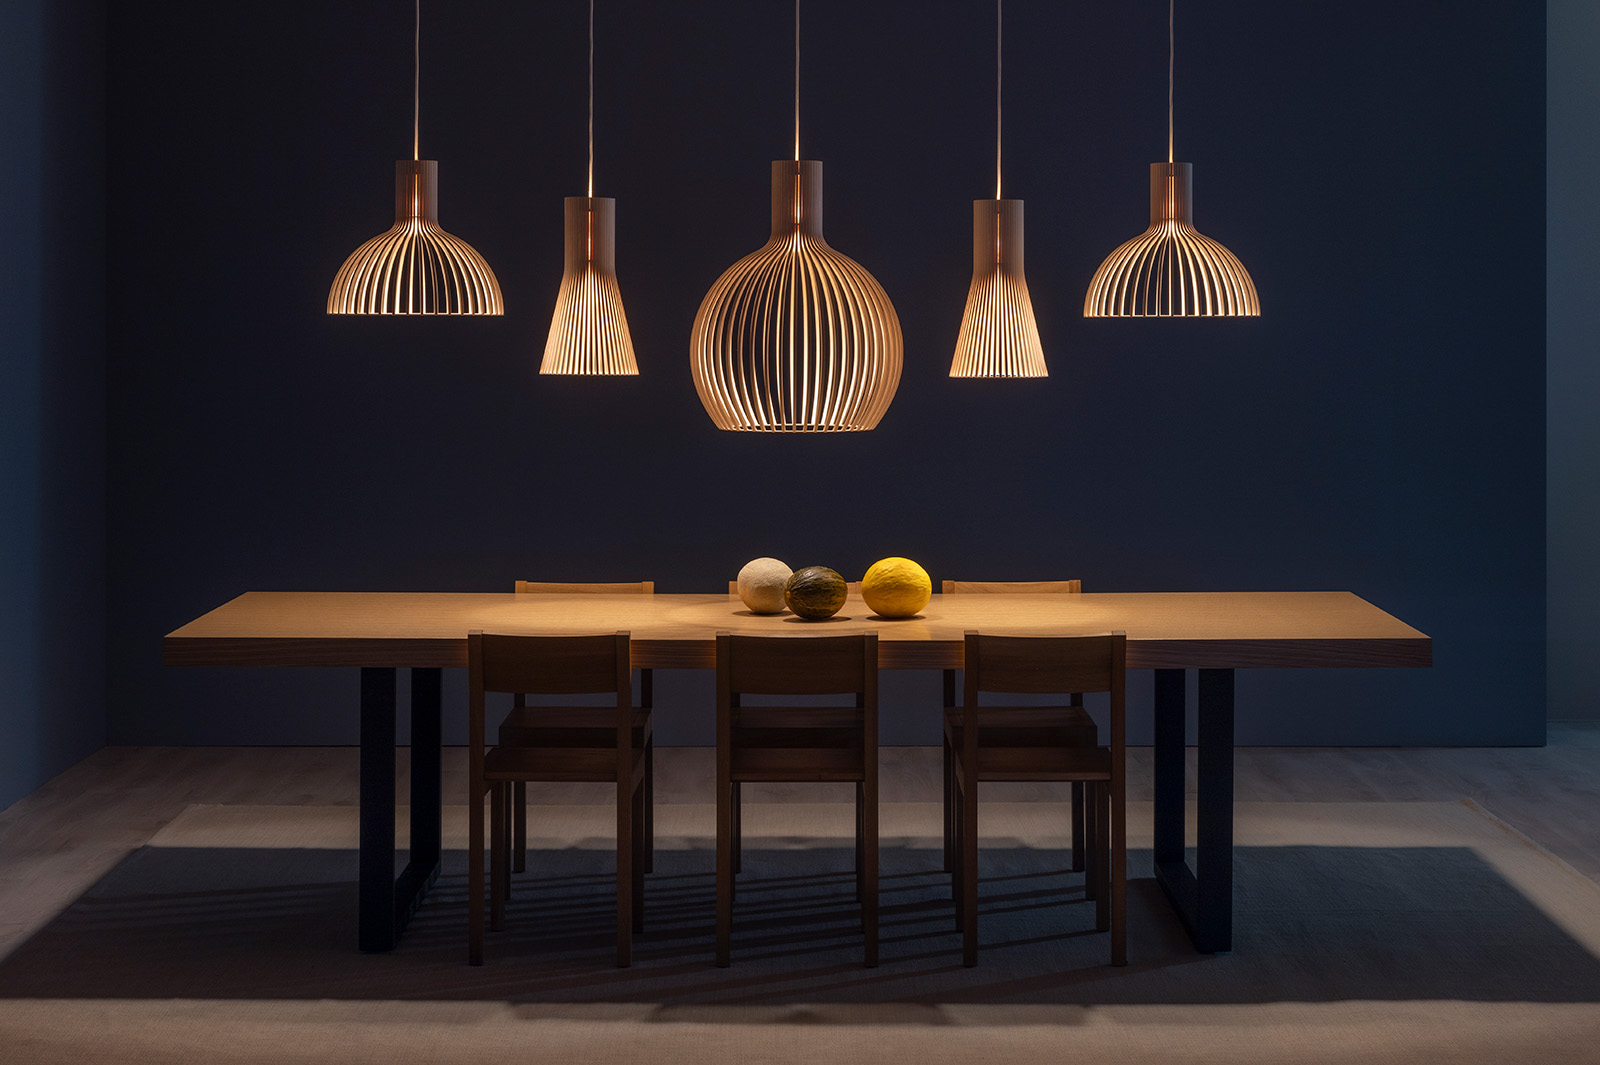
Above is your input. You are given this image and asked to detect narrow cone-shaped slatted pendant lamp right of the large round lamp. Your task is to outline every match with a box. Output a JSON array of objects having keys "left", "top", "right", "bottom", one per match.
[{"left": 950, "top": 0, "right": 1050, "bottom": 377}]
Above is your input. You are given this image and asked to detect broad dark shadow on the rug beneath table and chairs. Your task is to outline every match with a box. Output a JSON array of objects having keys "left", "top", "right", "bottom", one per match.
[{"left": 0, "top": 838, "right": 1600, "bottom": 1015}]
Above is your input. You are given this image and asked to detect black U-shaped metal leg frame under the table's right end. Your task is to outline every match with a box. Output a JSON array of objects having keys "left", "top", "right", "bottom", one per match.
[{"left": 1154, "top": 670, "right": 1234, "bottom": 955}]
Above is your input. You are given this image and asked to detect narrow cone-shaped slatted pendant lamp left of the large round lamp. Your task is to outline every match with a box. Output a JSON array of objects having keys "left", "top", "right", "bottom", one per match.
[{"left": 539, "top": 0, "right": 638, "bottom": 374}]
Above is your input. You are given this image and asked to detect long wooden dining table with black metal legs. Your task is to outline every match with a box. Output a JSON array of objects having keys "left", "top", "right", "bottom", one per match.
[{"left": 163, "top": 592, "right": 1434, "bottom": 953}]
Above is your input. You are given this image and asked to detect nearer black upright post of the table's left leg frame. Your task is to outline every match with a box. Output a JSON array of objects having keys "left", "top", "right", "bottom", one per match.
[{"left": 357, "top": 667, "right": 395, "bottom": 950}]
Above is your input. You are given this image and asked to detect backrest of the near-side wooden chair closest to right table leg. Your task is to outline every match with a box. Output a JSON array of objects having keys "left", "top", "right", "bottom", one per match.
[{"left": 965, "top": 632, "right": 1128, "bottom": 705}]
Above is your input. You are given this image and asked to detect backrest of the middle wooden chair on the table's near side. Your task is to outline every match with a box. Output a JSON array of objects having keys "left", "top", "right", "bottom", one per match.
[{"left": 717, "top": 632, "right": 878, "bottom": 702}]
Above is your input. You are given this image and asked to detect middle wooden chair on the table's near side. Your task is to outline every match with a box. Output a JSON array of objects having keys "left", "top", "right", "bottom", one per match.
[{"left": 717, "top": 632, "right": 878, "bottom": 967}]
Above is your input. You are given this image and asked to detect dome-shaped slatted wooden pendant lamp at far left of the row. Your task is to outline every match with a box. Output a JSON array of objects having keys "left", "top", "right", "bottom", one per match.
[{"left": 328, "top": 0, "right": 506, "bottom": 315}]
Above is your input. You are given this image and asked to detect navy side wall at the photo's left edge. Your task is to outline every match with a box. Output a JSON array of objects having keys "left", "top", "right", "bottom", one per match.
[{"left": 0, "top": 0, "right": 106, "bottom": 809}]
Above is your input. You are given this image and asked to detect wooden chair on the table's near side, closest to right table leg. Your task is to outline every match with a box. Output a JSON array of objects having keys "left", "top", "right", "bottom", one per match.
[{"left": 944, "top": 632, "right": 1128, "bottom": 966}]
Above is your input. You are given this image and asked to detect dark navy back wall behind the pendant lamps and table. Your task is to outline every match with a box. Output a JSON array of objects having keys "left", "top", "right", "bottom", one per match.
[{"left": 109, "top": 0, "right": 1546, "bottom": 744}]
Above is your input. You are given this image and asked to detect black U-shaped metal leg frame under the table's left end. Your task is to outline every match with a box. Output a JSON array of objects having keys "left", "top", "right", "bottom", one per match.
[{"left": 357, "top": 668, "right": 442, "bottom": 950}]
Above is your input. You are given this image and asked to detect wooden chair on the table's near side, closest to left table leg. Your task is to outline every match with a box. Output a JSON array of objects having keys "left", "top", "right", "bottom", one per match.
[{"left": 467, "top": 632, "right": 650, "bottom": 966}]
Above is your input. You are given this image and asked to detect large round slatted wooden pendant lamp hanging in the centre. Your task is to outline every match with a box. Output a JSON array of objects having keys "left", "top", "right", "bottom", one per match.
[{"left": 690, "top": 0, "right": 902, "bottom": 433}]
